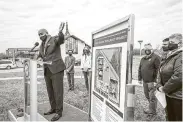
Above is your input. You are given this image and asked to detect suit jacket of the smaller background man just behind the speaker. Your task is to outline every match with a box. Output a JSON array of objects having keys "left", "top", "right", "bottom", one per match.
[{"left": 65, "top": 56, "right": 75, "bottom": 73}]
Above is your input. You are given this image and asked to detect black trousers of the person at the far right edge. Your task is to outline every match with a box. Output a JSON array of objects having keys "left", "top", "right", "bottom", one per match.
[{"left": 166, "top": 96, "right": 182, "bottom": 121}]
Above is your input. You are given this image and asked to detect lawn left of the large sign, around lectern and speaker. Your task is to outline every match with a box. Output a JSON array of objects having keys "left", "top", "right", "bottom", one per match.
[{"left": 0, "top": 79, "right": 88, "bottom": 121}]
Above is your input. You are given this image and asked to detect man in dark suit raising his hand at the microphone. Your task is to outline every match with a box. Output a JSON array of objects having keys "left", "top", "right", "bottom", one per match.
[{"left": 37, "top": 23, "right": 65, "bottom": 121}]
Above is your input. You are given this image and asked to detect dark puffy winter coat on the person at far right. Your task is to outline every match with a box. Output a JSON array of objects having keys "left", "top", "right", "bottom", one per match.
[{"left": 157, "top": 49, "right": 182, "bottom": 99}]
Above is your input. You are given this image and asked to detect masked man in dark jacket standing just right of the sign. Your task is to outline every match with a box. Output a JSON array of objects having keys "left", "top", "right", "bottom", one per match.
[{"left": 138, "top": 43, "right": 160, "bottom": 120}]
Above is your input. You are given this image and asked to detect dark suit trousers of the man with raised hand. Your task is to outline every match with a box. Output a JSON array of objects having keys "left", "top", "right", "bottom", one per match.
[{"left": 44, "top": 68, "right": 64, "bottom": 114}]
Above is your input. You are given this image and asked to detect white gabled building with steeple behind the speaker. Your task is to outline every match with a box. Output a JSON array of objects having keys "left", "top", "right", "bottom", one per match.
[{"left": 61, "top": 23, "right": 91, "bottom": 60}]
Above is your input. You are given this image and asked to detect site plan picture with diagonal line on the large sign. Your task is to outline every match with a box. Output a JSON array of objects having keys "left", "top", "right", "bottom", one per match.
[{"left": 94, "top": 47, "right": 122, "bottom": 107}]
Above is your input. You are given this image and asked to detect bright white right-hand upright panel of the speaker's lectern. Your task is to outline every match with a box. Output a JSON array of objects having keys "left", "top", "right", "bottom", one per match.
[{"left": 30, "top": 60, "right": 37, "bottom": 121}]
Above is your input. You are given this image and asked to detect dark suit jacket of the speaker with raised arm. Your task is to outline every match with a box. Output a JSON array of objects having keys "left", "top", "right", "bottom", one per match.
[{"left": 39, "top": 32, "right": 66, "bottom": 74}]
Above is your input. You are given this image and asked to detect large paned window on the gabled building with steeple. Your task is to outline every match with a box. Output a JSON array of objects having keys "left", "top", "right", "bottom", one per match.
[{"left": 65, "top": 37, "right": 78, "bottom": 54}]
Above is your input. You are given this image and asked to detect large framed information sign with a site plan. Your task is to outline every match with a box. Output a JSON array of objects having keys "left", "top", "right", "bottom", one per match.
[{"left": 89, "top": 15, "right": 134, "bottom": 121}]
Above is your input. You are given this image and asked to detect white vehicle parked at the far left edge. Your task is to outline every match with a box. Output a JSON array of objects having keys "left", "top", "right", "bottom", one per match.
[{"left": 0, "top": 60, "right": 16, "bottom": 69}]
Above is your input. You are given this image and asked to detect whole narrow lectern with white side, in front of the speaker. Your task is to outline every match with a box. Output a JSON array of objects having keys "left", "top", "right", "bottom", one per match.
[{"left": 24, "top": 60, "right": 37, "bottom": 121}]
